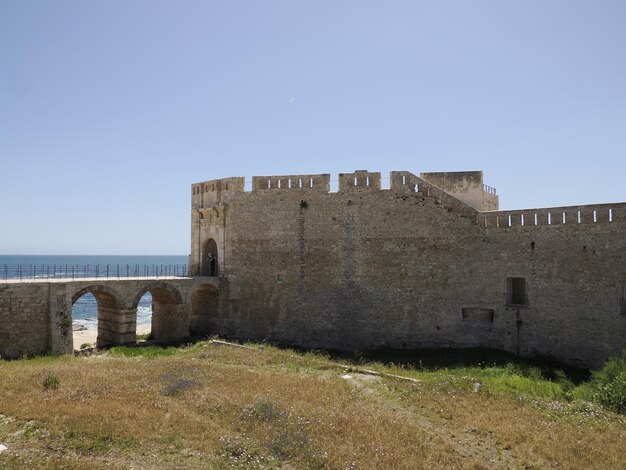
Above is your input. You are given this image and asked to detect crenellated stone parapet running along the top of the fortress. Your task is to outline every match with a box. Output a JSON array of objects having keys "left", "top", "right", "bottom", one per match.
[{"left": 192, "top": 170, "right": 626, "bottom": 229}]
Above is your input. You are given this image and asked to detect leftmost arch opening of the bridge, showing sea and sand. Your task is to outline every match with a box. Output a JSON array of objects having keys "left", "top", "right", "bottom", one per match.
[{"left": 72, "top": 285, "right": 124, "bottom": 349}]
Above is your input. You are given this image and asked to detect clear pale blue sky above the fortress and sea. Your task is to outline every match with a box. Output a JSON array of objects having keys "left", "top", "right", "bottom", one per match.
[{"left": 0, "top": 0, "right": 626, "bottom": 254}]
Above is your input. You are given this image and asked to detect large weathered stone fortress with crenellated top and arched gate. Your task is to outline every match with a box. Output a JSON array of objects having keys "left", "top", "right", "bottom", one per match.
[{"left": 190, "top": 171, "right": 626, "bottom": 367}]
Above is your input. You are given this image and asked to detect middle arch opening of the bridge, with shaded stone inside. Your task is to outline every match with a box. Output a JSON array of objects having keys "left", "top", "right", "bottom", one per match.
[{"left": 131, "top": 281, "right": 189, "bottom": 343}]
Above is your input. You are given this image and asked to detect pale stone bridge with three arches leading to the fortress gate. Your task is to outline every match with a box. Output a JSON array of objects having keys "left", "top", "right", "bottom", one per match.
[{"left": 0, "top": 277, "right": 220, "bottom": 358}]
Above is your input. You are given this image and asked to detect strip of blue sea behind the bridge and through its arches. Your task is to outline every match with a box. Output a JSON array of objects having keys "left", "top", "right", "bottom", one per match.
[{"left": 0, "top": 255, "right": 188, "bottom": 331}]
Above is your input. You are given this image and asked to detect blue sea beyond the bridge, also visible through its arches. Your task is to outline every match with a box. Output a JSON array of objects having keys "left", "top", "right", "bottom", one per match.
[{"left": 0, "top": 255, "right": 188, "bottom": 330}]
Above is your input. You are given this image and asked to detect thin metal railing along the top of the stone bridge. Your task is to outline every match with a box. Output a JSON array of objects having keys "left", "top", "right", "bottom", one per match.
[{"left": 0, "top": 264, "right": 189, "bottom": 281}]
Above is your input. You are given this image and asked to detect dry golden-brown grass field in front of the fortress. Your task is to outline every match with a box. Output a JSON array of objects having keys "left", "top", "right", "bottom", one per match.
[{"left": 0, "top": 341, "right": 626, "bottom": 469}]
